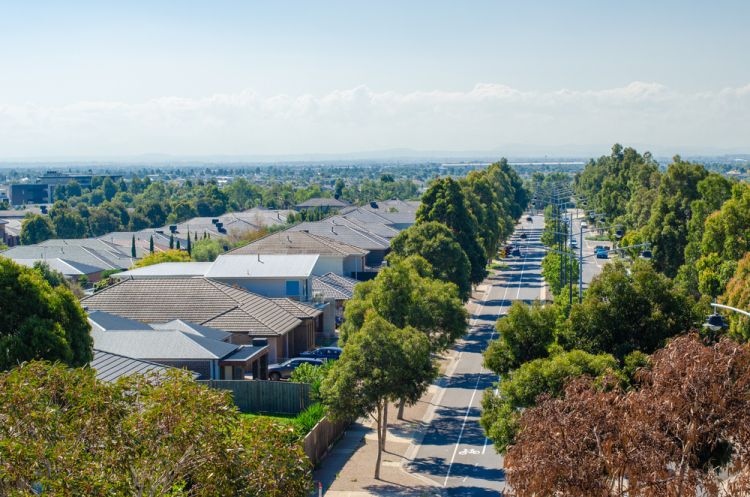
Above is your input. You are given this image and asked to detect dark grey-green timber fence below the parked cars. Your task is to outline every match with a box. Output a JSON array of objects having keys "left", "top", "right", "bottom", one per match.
[{"left": 199, "top": 380, "right": 313, "bottom": 415}]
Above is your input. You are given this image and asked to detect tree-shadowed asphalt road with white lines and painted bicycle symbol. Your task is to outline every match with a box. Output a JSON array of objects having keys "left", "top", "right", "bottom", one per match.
[{"left": 409, "top": 216, "right": 544, "bottom": 497}]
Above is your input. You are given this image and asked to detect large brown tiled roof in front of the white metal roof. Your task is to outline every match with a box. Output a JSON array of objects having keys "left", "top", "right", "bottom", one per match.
[{"left": 81, "top": 278, "right": 300, "bottom": 336}]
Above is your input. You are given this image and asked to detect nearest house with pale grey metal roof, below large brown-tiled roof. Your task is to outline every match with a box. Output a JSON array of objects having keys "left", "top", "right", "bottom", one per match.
[{"left": 89, "top": 311, "right": 268, "bottom": 380}]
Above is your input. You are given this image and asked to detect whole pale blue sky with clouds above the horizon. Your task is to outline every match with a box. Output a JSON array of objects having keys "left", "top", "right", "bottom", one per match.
[{"left": 0, "top": 0, "right": 750, "bottom": 159}]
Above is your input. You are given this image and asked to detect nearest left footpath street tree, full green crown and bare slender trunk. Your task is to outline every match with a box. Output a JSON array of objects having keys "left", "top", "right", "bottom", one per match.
[{"left": 321, "top": 313, "right": 436, "bottom": 478}]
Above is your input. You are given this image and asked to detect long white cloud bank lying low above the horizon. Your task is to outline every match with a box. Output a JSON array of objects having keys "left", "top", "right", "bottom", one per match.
[{"left": 0, "top": 82, "right": 750, "bottom": 158}]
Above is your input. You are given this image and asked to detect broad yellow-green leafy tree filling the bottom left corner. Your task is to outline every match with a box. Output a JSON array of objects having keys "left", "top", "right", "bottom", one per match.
[{"left": 0, "top": 362, "right": 312, "bottom": 497}]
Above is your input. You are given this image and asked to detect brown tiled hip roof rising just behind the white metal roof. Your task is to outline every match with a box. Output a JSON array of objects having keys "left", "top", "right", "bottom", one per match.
[{"left": 228, "top": 230, "right": 367, "bottom": 256}]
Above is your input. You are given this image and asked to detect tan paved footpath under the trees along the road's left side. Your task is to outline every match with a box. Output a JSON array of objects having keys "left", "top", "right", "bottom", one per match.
[{"left": 314, "top": 280, "right": 496, "bottom": 497}]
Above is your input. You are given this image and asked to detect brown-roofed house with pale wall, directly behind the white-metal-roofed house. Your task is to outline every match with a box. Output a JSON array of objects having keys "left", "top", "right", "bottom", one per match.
[{"left": 227, "top": 230, "right": 367, "bottom": 278}]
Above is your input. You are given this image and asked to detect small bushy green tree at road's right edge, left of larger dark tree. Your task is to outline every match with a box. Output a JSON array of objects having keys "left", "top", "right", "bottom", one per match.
[{"left": 484, "top": 301, "right": 558, "bottom": 375}]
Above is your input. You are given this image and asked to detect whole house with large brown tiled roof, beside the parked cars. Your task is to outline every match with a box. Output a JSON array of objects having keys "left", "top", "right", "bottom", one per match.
[{"left": 81, "top": 277, "right": 322, "bottom": 362}]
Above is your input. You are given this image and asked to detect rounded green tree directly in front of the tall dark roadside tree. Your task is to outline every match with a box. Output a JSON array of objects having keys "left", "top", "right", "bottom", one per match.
[{"left": 391, "top": 221, "right": 471, "bottom": 301}]
